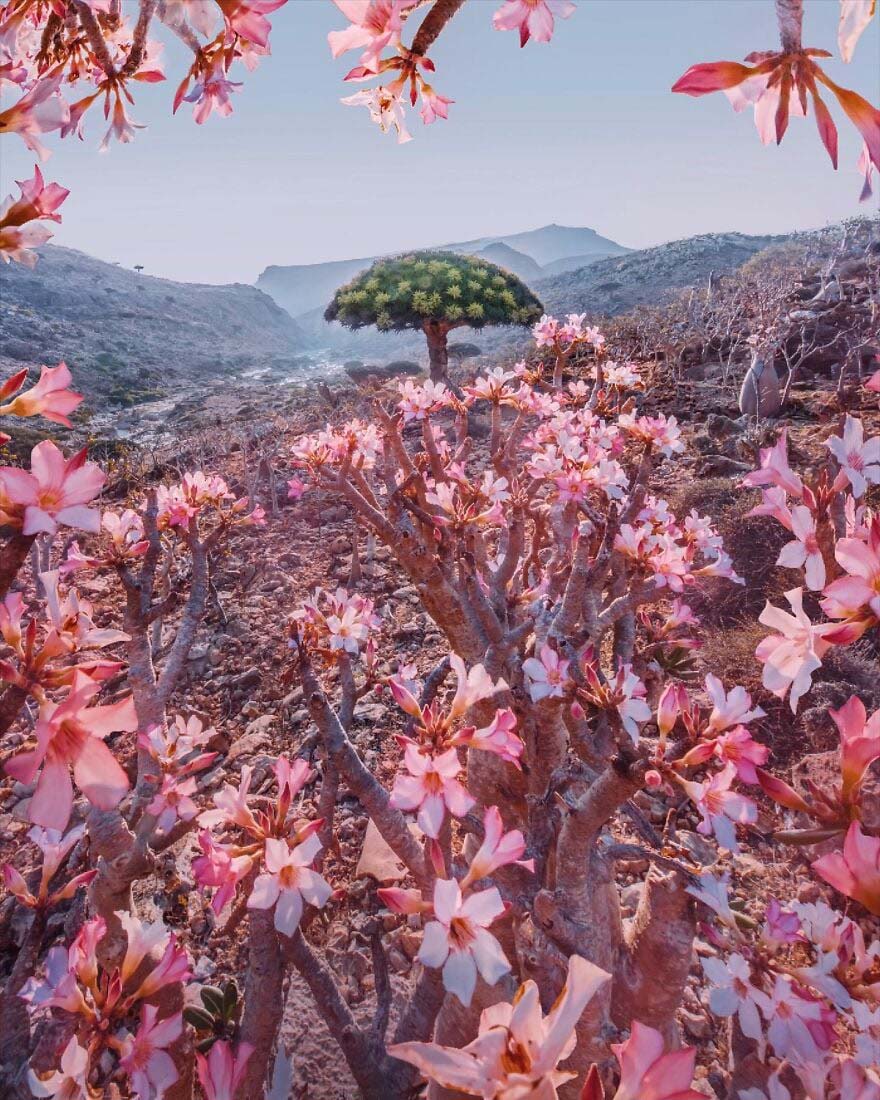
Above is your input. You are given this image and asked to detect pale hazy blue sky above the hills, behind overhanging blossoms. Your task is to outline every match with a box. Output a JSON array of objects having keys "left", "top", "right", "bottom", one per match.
[{"left": 0, "top": 0, "right": 880, "bottom": 283}]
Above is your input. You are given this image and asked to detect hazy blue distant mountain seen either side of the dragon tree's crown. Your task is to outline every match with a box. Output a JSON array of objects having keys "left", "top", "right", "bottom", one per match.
[{"left": 256, "top": 226, "right": 629, "bottom": 318}]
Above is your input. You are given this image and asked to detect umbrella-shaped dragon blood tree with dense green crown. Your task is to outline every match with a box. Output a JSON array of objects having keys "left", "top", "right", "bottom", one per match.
[{"left": 323, "top": 252, "right": 543, "bottom": 382}]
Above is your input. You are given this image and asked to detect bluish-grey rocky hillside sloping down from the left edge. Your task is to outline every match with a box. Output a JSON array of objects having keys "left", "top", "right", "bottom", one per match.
[{"left": 0, "top": 245, "right": 307, "bottom": 410}]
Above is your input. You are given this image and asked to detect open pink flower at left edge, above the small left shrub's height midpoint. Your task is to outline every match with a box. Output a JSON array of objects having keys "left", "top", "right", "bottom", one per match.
[{"left": 0, "top": 439, "right": 107, "bottom": 535}]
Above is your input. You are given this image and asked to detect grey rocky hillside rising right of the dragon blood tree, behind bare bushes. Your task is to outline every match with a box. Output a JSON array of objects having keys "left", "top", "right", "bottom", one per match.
[{"left": 531, "top": 233, "right": 787, "bottom": 316}]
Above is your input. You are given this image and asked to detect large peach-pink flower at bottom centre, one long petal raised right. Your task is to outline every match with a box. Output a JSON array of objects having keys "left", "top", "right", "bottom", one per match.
[{"left": 388, "top": 955, "right": 609, "bottom": 1100}]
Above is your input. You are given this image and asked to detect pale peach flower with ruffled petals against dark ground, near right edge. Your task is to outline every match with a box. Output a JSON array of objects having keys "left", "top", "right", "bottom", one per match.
[{"left": 755, "top": 589, "right": 834, "bottom": 712}]
